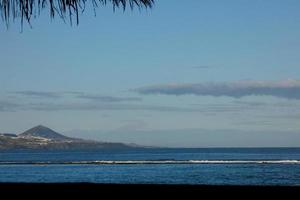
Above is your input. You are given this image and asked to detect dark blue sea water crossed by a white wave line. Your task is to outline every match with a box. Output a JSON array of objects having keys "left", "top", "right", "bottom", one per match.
[{"left": 0, "top": 148, "right": 300, "bottom": 185}]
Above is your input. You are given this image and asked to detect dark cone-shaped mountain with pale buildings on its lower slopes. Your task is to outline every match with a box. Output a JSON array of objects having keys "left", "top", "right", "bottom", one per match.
[{"left": 0, "top": 125, "right": 137, "bottom": 150}]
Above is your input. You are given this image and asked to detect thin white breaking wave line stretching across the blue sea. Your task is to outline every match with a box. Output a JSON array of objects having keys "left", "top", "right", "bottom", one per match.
[{"left": 0, "top": 160, "right": 300, "bottom": 165}]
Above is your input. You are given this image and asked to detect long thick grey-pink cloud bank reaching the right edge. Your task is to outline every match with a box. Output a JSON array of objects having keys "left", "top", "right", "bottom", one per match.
[{"left": 134, "top": 79, "right": 300, "bottom": 99}]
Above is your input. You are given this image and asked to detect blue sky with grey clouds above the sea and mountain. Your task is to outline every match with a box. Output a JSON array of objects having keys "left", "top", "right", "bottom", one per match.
[{"left": 0, "top": 0, "right": 300, "bottom": 147}]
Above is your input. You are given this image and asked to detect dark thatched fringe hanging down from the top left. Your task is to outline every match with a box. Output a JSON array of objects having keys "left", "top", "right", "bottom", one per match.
[{"left": 0, "top": 0, "right": 154, "bottom": 26}]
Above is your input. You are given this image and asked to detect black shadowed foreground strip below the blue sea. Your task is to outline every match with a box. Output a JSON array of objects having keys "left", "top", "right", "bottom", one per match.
[{"left": 0, "top": 183, "right": 300, "bottom": 199}]
